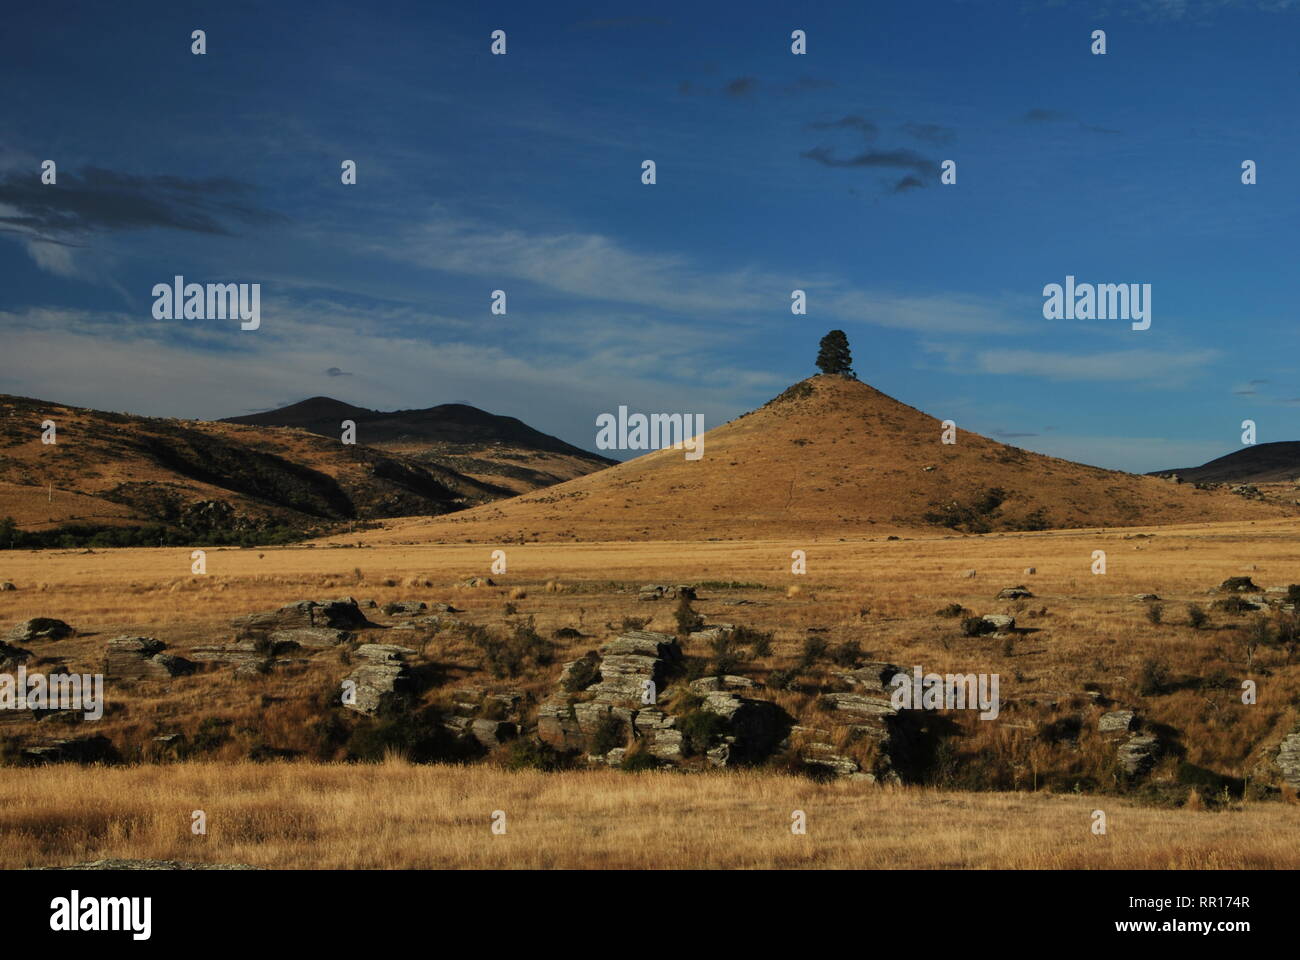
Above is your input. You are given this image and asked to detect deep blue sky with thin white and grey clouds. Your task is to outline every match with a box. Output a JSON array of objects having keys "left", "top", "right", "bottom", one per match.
[{"left": 0, "top": 0, "right": 1300, "bottom": 471}]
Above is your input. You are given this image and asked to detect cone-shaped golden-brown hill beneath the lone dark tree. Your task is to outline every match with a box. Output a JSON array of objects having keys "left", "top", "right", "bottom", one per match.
[{"left": 367, "top": 376, "right": 1296, "bottom": 541}]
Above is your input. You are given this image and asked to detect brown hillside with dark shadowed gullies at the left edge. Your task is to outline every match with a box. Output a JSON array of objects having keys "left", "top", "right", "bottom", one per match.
[{"left": 0, "top": 395, "right": 510, "bottom": 537}]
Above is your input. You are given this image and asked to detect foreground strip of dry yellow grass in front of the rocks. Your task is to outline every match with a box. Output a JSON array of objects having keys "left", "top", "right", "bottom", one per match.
[{"left": 0, "top": 761, "right": 1300, "bottom": 869}]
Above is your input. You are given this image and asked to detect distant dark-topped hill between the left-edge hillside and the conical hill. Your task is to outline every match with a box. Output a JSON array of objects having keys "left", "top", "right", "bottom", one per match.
[{"left": 222, "top": 397, "right": 614, "bottom": 493}]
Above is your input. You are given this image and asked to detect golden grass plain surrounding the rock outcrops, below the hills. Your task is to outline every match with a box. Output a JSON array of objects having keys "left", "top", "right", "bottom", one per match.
[{"left": 0, "top": 520, "right": 1300, "bottom": 869}]
